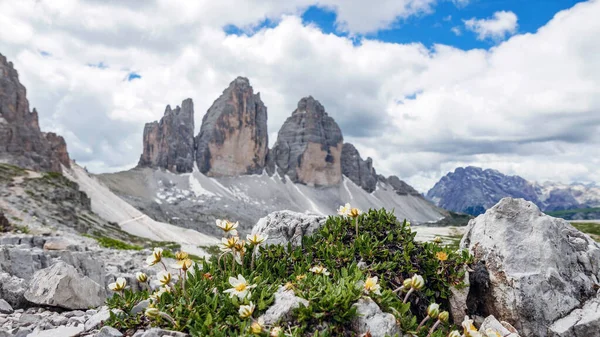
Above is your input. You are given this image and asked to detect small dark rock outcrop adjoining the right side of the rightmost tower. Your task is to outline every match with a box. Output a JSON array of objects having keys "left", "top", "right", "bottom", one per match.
[{"left": 342, "top": 143, "right": 377, "bottom": 193}]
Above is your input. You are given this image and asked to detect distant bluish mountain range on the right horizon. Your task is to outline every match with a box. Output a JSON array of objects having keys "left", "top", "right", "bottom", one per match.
[{"left": 426, "top": 166, "right": 600, "bottom": 218}]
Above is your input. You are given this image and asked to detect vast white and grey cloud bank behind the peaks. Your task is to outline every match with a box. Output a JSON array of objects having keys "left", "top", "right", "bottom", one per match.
[{"left": 0, "top": 0, "right": 600, "bottom": 191}]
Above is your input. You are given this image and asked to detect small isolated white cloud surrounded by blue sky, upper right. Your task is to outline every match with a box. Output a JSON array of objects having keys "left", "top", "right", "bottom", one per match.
[{"left": 464, "top": 11, "right": 518, "bottom": 40}]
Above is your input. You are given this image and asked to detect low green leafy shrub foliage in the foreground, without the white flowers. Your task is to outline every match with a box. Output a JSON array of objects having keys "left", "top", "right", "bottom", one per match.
[{"left": 108, "top": 210, "right": 471, "bottom": 337}]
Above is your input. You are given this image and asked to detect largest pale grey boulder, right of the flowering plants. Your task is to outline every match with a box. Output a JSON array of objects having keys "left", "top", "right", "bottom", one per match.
[{"left": 461, "top": 198, "right": 600, "bottom": 337}]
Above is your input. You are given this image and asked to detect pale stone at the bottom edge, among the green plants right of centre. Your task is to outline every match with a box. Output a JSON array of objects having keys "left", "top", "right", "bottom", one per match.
[{"left": 351, "top": 297, "right": 401, "bottom": 337}]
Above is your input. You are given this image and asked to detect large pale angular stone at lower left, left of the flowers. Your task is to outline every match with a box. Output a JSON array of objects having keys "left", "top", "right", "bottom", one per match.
[{"left": 25, "top": 261, "right": 105, "bottom": 309}]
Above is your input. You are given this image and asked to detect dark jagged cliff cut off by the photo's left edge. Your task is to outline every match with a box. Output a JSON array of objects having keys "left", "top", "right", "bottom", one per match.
[{"left": 0, "top": 54, "right": 70, "bottom": 172}]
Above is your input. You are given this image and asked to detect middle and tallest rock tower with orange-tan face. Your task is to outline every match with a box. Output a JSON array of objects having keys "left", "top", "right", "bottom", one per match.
[{"left": 196, "top": 77, "right": 269, "bottom": 176}]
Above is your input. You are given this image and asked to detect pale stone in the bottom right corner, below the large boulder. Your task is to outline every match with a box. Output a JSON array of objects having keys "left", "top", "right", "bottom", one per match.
[{"left": 549, "top": 294, "right": 600, "bottom": 337}]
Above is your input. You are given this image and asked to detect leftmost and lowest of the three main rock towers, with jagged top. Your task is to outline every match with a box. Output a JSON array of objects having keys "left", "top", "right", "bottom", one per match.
[{"left": 138, "top": 98, "right": 194, "bottom": 173}]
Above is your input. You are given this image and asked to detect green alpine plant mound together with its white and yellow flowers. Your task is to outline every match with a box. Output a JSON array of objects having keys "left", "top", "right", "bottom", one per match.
[{"left": 102, "top": 205, "right": 506, "bottom": 337}]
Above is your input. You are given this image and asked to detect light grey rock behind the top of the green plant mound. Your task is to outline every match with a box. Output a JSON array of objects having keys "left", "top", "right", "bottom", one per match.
[{"left": 252, "top": 211, "right": 327, "bottom": 246}]
